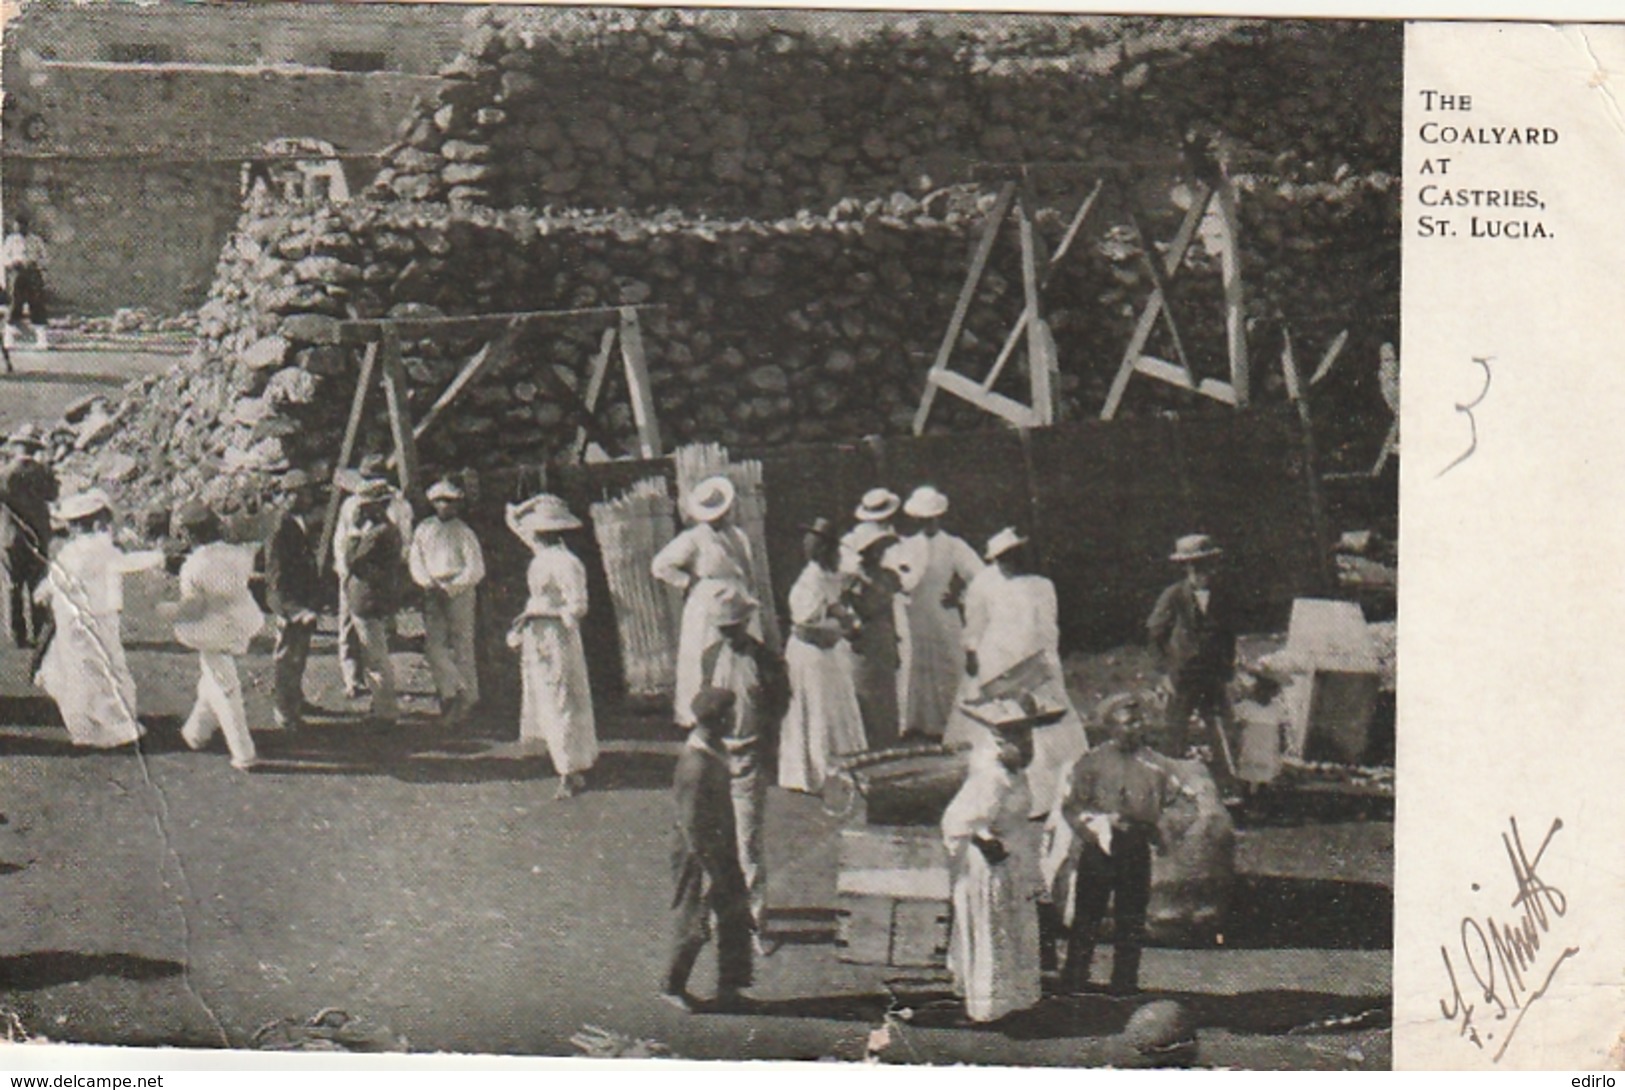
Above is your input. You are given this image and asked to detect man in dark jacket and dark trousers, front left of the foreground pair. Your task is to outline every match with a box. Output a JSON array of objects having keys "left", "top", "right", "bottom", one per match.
[{"left": 660, "top": 686, "right": 751, "bottom": 1010}]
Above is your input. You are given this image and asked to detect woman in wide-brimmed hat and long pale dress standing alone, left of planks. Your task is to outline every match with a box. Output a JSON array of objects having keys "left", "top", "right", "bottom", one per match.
[{"left": 507, "top": 492, "right": 598, "bottom": 799}]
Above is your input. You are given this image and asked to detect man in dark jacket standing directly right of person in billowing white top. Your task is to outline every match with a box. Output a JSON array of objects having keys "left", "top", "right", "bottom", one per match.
[{"left": 265, "top": 469, "right": 322, "bottom": 731}]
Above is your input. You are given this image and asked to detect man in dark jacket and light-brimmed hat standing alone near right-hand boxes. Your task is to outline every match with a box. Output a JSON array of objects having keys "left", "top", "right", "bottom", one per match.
[{"left": 1146, "top": 534, "right": 1235, "bottom": 783}]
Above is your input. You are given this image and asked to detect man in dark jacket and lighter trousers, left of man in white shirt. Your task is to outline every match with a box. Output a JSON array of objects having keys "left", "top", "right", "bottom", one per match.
[{"left": 340, "top": 481, "right": 405, "bottom": 726}]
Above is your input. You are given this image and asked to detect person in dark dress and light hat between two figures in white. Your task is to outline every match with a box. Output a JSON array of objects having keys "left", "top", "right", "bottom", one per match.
[{"left": 845, "top": 523, "right": 902, "bottom": 749}]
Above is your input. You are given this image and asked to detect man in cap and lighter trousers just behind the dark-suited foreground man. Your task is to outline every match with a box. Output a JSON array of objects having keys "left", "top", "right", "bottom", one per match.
[{"left": 700, "top": 591, "right": 790, "bottom": 935}]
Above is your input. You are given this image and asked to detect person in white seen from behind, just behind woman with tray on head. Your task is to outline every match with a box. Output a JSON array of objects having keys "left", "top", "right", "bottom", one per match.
[{"left": 943, "top": 528, "right": 1089, "bottom": 817}]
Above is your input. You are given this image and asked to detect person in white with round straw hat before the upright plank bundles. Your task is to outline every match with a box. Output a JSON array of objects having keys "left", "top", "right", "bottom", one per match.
[{"left": 648, "top": 476, "right": 762, "bottom": 729}]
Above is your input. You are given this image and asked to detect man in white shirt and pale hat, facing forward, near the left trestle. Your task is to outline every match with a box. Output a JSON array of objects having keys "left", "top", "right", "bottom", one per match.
[{"left": 408, "top": 479, "right": 486, "bottom": 721}]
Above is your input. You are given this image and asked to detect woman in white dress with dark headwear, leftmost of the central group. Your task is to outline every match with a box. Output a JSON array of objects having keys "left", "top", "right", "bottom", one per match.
[{"left": 778, "top": 518, "right": 866, "bottom": 791}]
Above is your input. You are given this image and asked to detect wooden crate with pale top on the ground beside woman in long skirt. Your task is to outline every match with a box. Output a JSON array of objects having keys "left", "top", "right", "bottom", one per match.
[{"left": 835, "top": 825, "right": 951, "bottom": 968}]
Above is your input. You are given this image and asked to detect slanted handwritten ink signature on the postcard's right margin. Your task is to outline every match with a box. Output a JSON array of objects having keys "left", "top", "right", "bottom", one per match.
[{"left": 1438, "top": 817, "right": 1580, "bottom": 1062}]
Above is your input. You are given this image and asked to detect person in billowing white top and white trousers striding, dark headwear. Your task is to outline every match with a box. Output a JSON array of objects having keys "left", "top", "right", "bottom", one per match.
[{"left": 159, "top": 500, "right": 265, "bottom": 772}]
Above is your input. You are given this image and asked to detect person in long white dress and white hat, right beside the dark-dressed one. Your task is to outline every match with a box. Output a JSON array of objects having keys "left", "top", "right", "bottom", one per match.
[{"left": 894, "top": 484, "right": 982, "bottom": 737}]
